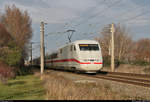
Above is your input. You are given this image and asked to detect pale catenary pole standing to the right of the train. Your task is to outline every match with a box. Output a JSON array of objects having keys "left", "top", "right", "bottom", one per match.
[{"left": 111, "top": 23, "right": 115, "bottom": 72}]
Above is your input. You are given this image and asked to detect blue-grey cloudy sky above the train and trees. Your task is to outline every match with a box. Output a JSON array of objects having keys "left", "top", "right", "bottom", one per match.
[{"left": 0, "top": 0, "right": 150, "bottom": 58}]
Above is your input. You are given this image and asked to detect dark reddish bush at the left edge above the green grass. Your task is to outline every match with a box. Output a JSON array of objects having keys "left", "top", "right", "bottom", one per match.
[{"left": 0, "top": 62, "right": 15, "bottom": 84}]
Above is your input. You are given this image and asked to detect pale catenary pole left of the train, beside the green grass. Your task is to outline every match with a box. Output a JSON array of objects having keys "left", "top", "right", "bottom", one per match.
[{"left": 40, "top": 22, "right": 44, "bottom": 75}]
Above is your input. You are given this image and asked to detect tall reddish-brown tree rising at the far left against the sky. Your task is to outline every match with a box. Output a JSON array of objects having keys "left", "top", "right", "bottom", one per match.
[{"left": 0, "top": 5, "right": 32, "bottom": 63}]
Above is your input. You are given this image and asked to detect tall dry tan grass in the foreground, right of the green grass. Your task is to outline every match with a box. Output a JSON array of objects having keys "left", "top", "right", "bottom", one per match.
[{"left": 34, "top": 73, "right": 136, "bottom": 100}]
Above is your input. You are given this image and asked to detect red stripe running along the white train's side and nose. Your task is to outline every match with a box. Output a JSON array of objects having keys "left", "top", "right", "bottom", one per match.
[{"left": 46, "top": 59, "right": 102, "bottom": 64}]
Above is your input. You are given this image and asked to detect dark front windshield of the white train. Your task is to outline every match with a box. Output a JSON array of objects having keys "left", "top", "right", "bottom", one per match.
[{"left": 79, "top": 44, "right": 99, "bottom": 51}]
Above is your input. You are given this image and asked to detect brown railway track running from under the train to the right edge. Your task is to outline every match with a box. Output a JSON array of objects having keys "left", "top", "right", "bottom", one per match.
[{"left": 44, "top": 71, "right": 150, "bottom": 88}]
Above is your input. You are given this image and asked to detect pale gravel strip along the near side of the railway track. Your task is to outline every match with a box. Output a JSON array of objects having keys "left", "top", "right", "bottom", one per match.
[{"left": 49, "top": 71, "right": 150, "bottom": 100}]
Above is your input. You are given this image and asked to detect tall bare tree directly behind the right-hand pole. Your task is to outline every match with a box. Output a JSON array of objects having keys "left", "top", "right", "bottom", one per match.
[{"left": 97, "top": 24, "right": 132, "bottom": 60}]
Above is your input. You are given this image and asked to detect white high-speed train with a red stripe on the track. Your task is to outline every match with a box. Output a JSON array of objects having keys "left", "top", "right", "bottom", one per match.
[{"left": 46, "top": 40, "right": 103, "bottom": 73}]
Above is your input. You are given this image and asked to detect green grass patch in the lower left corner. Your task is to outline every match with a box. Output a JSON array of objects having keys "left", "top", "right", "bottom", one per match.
[{"left": 0, "top": 75, "right": 45, "bottom": 100}]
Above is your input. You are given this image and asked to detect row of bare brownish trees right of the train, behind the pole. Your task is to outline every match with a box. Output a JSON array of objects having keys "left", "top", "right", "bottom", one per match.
[{"left": 96, "top": 23, "right": 150, "bottom": 65}]
